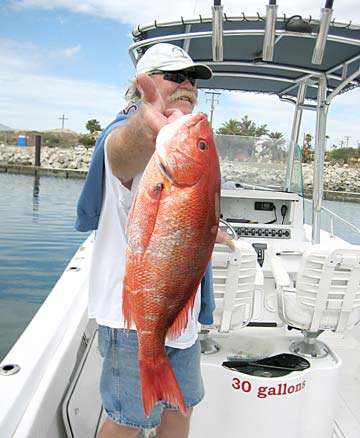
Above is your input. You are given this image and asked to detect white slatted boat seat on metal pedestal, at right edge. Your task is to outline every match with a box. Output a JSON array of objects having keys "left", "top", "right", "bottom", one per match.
[{"left": 272, "top": 244, "right": 360, "bottom": 357}]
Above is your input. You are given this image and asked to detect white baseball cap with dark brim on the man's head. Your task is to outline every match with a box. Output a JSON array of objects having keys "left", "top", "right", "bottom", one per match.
[{"left": 136, "top": 43, "right": 212, "bottom": 79}]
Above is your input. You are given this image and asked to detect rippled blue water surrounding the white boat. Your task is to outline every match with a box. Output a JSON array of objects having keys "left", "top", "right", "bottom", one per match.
[{"left": 0, "top": 173, "right": 360, "bottom": 360}]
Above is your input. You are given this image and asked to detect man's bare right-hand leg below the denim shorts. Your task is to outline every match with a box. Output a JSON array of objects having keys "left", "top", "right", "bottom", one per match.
[{"left": 156, "top": 408, "right": 193, "bottom": 438}]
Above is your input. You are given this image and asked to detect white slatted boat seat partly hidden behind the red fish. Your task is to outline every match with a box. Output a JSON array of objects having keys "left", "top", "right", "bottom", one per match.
[{"left": 212, "top": 239, "right": 264, "bottom": 332}]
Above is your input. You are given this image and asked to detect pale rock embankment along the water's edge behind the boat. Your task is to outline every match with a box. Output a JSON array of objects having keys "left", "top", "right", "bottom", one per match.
[{"left": 0, "top": 146, "right": 360, "bottom": 198}]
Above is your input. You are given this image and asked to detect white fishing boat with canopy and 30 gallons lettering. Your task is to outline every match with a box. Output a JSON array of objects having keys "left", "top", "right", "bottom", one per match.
[{"left": 0, "top": 0, "right": 360, "bottom": 438}]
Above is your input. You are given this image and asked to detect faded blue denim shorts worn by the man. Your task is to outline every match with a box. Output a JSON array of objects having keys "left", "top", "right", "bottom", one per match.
[{"left": 99, "top": 326, "right": 204, "bottom": 429}]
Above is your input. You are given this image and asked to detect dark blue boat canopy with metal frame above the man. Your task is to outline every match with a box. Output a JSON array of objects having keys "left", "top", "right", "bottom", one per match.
[{"left": 129, "top": 14, "right": 360, "bottom": 100}]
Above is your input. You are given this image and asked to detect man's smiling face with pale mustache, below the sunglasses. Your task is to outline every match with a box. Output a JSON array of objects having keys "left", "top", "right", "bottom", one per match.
[{"left": 150, "top": 73, "right": 198, "bottom": 114}]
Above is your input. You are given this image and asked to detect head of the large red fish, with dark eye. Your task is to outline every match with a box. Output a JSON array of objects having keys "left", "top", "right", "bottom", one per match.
[{"left": 155, "top": 113, "right": 220, "bottom": 186}]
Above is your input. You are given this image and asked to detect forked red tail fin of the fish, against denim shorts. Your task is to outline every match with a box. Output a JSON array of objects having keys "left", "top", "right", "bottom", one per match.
[{"left": 140, "top": 355, "right": 186, "bottom": 416}]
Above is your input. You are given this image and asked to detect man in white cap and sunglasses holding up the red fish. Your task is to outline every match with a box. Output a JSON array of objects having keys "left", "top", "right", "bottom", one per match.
[{"left": 76, "top": 44, "right": 214, "bottom": 438}]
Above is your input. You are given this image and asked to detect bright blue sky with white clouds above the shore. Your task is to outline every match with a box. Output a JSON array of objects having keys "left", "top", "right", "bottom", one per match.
[{"left": 0, "top": 0, "right": 360, "bottom": 146}]
